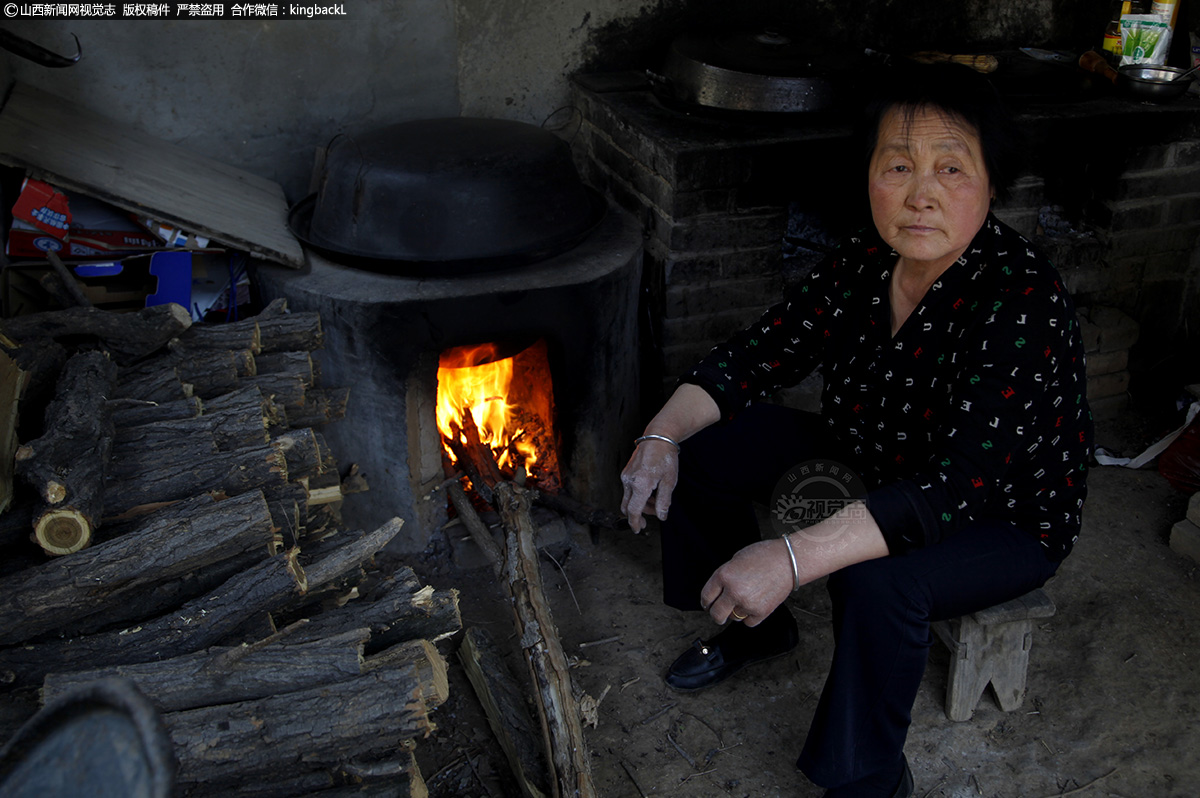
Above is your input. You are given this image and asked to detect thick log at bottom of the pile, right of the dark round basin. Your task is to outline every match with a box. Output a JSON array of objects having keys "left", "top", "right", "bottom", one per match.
[{"left": 163, "top": 666, "right": 434, "bottom": 791}]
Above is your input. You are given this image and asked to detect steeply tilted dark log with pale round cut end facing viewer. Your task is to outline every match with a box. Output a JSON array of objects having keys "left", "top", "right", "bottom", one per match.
[{"left": 16, "top": 352, "right": 116, "bottom": 554}]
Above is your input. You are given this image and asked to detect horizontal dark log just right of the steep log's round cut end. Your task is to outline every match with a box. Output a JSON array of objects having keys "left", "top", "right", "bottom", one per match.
[{"left": 104, "top": 445, "right": 287, "bottom": 516}]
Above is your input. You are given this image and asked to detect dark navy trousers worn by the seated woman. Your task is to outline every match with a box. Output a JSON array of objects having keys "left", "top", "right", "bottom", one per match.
[{"left": 662, "top": 404, "right": 1057, "bottom": 787}]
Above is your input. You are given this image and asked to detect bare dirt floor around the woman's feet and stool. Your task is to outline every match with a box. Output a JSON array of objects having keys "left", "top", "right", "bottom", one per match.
[{"left": 412, "top": 410, "right": 1200, "bottom": 798}]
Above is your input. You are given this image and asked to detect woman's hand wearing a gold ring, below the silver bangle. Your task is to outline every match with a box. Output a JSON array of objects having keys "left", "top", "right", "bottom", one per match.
[{"left": 700, "top": 540, "right": 793, "bottom": 626}]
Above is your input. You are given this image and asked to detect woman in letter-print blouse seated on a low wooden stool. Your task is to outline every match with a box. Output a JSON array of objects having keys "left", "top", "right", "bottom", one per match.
[{"left": 622, "top": 65, "right": 1092, "bottom": 798}]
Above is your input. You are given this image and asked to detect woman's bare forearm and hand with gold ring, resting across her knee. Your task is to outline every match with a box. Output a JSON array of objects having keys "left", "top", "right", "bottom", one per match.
[{"left": 700, "top": 502, "right": 888, "bottom": 626}]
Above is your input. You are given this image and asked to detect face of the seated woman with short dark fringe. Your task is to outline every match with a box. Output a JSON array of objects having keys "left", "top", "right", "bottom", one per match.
[{"left": 869, "top": 108, "right": 994, "bottom": 271}]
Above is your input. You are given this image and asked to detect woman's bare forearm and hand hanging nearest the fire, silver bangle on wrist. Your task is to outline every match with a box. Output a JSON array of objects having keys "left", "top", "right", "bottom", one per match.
[{"left": 620, "top": 384, "right": 721, "bottom": 532}]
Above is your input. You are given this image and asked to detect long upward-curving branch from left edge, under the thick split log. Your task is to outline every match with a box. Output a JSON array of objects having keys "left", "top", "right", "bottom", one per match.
[{"left": 0, "top": 548, "right": 304, "bottom": 685}]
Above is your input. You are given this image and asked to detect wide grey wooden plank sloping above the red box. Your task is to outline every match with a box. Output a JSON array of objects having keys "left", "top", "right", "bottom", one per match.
[{"left": 0, "top": 84, "right": 305, "bottom": 268}]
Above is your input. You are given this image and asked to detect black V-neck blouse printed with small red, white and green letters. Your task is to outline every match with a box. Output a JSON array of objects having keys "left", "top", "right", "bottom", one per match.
[{"left": 682, "top": 215, "right": 1092, "bottom": 562}]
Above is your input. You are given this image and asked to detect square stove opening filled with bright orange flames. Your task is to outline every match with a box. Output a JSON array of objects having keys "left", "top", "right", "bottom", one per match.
[{"left": 437, "top": 338, "right": 562, "bottom": 492}]
